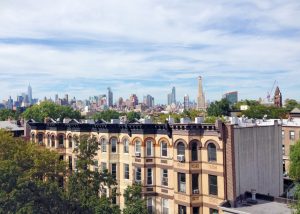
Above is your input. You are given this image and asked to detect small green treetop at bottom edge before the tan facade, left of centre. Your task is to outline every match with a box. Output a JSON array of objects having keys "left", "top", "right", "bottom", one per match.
[{"left": 123, "top": 184, "right": 148, "bottom": 214}]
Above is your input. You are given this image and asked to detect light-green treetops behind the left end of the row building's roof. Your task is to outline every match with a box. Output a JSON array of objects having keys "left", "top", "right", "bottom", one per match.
[{"left": 22, "top": 101, "right": 80, "bottom": 122}]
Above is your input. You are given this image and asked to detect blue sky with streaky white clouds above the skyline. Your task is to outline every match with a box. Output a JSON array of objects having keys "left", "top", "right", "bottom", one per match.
[{"left": 0, "top": 0, "right": 300, "bottom": 103}]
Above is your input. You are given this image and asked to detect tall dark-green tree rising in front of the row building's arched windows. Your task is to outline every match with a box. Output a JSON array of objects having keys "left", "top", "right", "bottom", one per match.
[{"left": 67, "top": 135, "right": 120, "bottom": 214}]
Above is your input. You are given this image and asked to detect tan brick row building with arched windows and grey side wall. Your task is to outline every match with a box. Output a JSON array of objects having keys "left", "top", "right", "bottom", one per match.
[{"left": 30, "top": 120, "right": 283, "bottom": 214}]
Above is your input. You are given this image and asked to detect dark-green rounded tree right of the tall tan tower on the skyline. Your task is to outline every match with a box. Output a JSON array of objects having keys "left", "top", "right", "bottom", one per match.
[{"left": 207, "top": 99, "right": 231, "bottom": 117}]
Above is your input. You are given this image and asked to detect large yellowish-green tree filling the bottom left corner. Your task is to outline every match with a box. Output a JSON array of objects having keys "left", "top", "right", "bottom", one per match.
[{"left": 0, "top": 130, "right": 72, "bottom": 213}]
